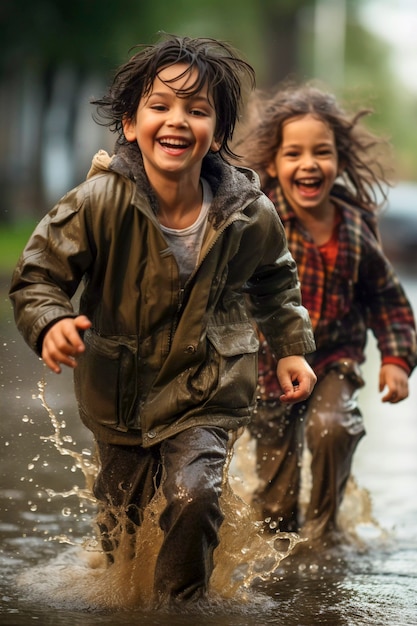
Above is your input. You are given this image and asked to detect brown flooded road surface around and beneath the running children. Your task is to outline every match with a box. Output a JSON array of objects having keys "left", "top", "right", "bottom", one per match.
[{"left": 0, "top": 277, "right": 417, "bottom": 626}]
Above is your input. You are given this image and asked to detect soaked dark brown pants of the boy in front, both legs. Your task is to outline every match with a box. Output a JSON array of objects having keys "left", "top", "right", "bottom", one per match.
[{"left": 94, "top": 427, "right": 228, "bottom": 601}]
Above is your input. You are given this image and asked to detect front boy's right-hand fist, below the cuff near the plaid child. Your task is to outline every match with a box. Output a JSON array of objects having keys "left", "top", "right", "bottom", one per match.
[{"left": 277, "top": 356, "right": 317, "bottom": 403}]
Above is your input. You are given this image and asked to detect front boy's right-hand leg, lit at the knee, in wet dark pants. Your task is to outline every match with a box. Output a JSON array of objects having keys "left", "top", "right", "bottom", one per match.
[{"left": 154, "top": 427, "right": 228, "bottom": 601}]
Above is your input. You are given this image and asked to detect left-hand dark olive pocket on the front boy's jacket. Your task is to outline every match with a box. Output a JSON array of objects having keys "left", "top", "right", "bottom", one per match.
[{"left": 74, "top": 331, "right": 140, "bottom": 431}]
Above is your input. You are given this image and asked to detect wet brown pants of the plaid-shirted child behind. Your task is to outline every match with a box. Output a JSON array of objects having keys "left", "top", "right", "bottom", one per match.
[{"left": 250, "top": 360, "right": 365, "bottom": 537}]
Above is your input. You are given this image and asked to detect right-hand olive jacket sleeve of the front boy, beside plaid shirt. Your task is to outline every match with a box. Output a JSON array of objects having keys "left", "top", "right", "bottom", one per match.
[{"left": 237, "top": 197, "right": 315, "bottom": 359}]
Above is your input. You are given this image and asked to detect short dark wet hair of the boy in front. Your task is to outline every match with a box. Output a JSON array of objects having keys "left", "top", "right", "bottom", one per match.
[{"left": 92, "top": 34, "right": 255, "bottom": 157}]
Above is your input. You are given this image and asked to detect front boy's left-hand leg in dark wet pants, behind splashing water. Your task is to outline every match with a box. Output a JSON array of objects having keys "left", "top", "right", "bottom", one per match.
[{"left": 93, "top": 442, "right": 160, "bottom": 562}]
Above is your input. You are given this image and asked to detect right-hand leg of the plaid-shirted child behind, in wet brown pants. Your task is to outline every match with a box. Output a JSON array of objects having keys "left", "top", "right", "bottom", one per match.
[{"left": 303, "top": 361, "right": 365, "bottom": 539}]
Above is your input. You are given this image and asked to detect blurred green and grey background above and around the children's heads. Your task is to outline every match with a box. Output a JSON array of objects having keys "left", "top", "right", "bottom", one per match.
[{"left": 0, "top": 0, "right": 417, "bottom": 275}]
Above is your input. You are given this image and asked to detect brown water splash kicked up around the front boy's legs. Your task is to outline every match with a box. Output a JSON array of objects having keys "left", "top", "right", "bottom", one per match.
[{"left": 18, "top": 381, "right": 301, "bottom": 610}]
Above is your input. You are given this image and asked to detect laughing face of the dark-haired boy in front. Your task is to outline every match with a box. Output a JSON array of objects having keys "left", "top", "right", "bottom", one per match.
[{"left": 123, "top": 63, "right": 219, "bottom": 184}]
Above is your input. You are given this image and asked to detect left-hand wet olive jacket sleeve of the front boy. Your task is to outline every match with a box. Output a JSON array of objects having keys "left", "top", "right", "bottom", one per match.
[{"left": 9, "top": 186, "right": 94, "bottom": 354}]
